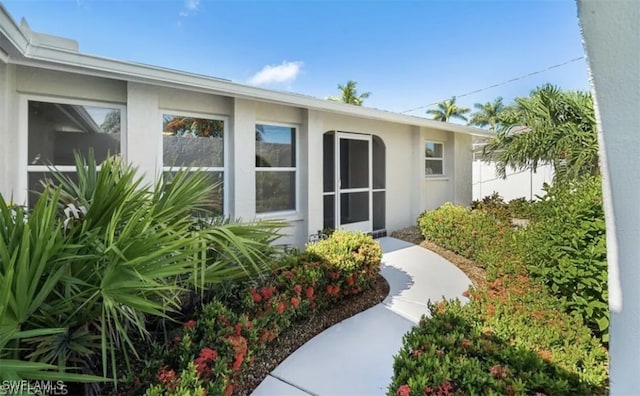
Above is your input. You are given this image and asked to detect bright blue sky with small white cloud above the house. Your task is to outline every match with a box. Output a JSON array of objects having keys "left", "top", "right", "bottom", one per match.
[{"left": 0, "top": 0, "right": 589, "bottom": 121}]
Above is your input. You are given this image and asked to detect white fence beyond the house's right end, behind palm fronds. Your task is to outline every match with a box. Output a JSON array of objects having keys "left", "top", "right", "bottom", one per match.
[{"left": 473, "top": 160, "right": 553, "bottom": 201}]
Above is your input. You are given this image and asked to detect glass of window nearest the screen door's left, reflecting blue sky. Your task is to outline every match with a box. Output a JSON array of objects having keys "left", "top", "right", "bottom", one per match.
[{"left": 256, "top": 124, "right": 297, "bottom": 213}]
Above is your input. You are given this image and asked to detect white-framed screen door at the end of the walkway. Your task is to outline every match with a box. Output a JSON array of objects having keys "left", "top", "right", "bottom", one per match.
[{"left": 335, "top": 133, "right": 373, "bottom": 232}]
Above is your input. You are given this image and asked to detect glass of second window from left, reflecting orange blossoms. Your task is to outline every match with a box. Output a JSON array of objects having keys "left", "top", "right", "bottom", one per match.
[{"left": 162, "top": 113, "right": 226, "bottom": 215}]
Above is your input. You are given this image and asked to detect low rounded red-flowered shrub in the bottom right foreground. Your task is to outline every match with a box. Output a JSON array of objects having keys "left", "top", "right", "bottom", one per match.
[{"left": 388, "top": 286, "right": 607, "bottom": 395}]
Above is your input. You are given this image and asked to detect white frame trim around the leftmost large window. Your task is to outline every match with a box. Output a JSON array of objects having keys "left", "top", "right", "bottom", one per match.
[{"left": 21, "top": 94, "right": 127, "bottom": 205}]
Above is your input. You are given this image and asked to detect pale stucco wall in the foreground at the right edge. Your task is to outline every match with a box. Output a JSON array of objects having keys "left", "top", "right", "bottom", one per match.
[{"left": 578, "top": 0, "right": 640, "bottom": 395}]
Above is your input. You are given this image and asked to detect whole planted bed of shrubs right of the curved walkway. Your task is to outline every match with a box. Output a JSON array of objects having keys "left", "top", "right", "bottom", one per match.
[{"left": 388, "top": 182, "right": 608, "bottom": 396}]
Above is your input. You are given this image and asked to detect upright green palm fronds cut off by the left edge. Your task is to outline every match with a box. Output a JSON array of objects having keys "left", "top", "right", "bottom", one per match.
[{"left": 0, "top": 191, "right": 105, "bottom": 382}]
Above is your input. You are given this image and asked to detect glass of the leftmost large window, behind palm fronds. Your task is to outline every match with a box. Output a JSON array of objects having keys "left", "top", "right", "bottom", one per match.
[{"left": 27, "top": 98, "right": 125, "bottom": 207}]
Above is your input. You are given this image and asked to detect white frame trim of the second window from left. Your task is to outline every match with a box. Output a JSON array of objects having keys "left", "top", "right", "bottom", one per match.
[{"left": 158, "top": 108, "right": 231, "bottom": 217}]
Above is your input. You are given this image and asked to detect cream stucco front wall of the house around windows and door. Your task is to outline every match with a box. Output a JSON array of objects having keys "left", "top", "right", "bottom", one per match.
[{"left": 0, "top": 63, "right": 471, "bottom": 247}]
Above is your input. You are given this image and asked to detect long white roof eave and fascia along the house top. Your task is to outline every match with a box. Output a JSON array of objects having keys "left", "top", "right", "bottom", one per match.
[{"left": 0, "top": 4, "right": 493, "bottom": 136}]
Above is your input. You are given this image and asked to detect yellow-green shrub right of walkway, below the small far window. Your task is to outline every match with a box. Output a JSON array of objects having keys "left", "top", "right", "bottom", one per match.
[{"left": 418, "top": 203, "right": 509, "bottom": 260}]
